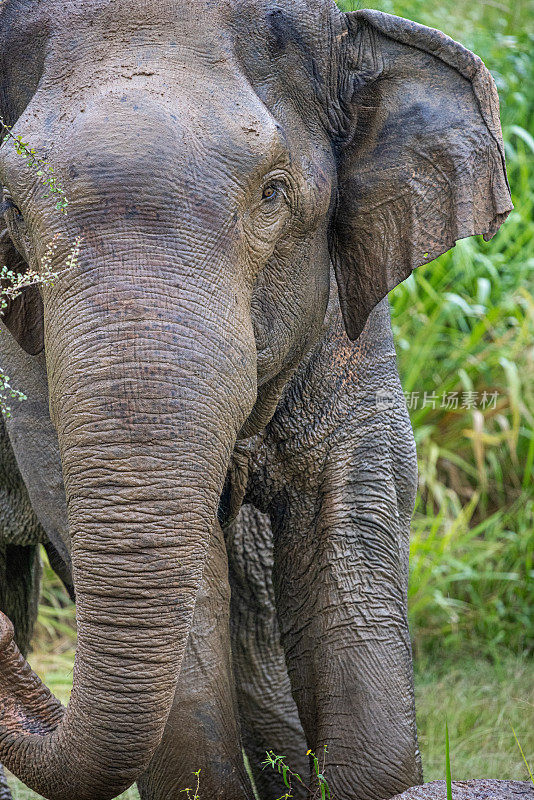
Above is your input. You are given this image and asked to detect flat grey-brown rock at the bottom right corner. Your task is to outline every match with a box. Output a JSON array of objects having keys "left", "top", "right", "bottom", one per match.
[{"left": 392, "top": 780, "right": 534, "bottom": 800}]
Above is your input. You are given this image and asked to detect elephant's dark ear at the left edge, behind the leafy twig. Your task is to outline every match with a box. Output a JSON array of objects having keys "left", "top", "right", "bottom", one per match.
[{"left": 0, "top": 223, "right": 44, "bottom": 356}]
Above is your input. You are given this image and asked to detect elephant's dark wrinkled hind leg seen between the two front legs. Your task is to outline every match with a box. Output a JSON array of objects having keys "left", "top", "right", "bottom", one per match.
[{"left": 227, "top": 505, "right": 307, "bottom": 800}]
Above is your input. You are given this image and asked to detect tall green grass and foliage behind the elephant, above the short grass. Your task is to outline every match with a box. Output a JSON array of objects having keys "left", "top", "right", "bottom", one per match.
[{"left": 340, "top": 0, "right": 534, "bottom": 658}]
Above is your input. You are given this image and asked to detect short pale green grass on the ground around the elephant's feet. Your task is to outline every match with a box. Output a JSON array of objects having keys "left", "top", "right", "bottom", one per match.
[{"left": 12, "top": 654, "right": 534, "bottom": 800}]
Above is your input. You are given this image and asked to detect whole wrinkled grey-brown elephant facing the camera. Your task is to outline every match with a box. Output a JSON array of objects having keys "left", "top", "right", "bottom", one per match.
[{"left": 0, "top": 0, "right": 512, "bottom": 800}]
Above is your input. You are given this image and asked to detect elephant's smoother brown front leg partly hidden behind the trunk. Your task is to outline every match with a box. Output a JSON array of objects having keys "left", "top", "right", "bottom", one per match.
[{"left": 138, "top": 523, "right": 252, "bottom": 800}]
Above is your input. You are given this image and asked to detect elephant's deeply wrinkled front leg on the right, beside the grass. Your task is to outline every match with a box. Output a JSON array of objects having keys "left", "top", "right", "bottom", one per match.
[{"left": 271, "top": 412, "right": 422, "bottom": 800}]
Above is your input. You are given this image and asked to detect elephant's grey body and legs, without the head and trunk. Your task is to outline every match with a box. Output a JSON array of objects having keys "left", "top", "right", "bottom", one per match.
[{"left": 0, "top": 293, "right": 421, "bottom": 800}]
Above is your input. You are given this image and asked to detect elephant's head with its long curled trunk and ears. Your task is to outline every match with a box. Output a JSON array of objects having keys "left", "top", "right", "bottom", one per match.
[{"left": 0, "top": 0, "right": 511, "bottom": 800}]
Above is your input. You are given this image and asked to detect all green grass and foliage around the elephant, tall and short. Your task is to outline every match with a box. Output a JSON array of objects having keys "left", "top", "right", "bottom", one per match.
[{"left": 6, "top": 0, "right": 534, "bottom": 798}]
